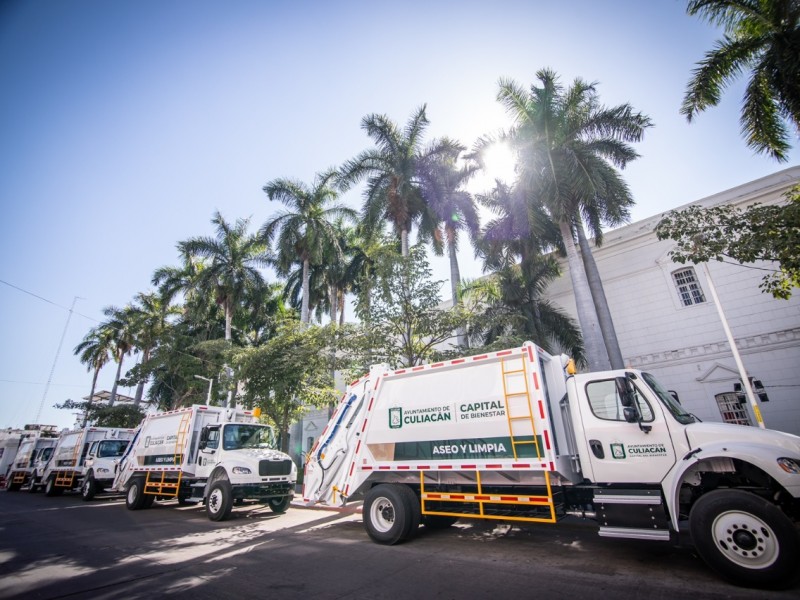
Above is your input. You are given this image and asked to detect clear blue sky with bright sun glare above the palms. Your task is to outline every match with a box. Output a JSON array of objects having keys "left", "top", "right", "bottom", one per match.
[{"left": 0, "top": 0, "right": 800, "bottom": 427}]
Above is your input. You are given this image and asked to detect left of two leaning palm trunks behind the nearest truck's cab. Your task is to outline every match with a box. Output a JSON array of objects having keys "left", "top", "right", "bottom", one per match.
[{"left": 558, "top": 219, "right": 611, "bottom": 371}]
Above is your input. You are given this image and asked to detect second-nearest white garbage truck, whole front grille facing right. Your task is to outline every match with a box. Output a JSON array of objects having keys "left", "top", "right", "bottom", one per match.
[{"left": 114, "top": 405, "right": 297, "bottom": 521}]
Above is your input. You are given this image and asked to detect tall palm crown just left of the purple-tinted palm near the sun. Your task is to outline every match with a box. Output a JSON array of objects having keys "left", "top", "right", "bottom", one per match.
[{"left": 338, "top": 105, "right": 457, "bottom": 256}]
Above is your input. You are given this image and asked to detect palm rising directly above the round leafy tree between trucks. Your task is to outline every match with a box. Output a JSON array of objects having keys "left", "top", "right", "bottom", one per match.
[{"left": 260, "top": 170, "right": 355, "bottom": 323}]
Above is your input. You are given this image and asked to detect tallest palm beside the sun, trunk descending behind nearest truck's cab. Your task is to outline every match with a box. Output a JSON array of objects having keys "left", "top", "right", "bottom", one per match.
[{"left": 498, "top": 69, "right": 652, "bottom": 370}]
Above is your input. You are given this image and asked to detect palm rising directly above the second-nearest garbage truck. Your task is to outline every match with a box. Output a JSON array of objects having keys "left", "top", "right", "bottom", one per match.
[{"left": 178, "top": 211, "right": 271, "bottom": 341}]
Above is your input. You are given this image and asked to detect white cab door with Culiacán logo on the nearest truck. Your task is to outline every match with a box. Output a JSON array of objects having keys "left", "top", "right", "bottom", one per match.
[{"left": 575, "top": 373, "right": 675, "bottom": 483}]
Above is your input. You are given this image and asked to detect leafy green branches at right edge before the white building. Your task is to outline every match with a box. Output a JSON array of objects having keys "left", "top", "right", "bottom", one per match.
[{"left": 655, "top": 186, "right": 800, "bottom": 300}]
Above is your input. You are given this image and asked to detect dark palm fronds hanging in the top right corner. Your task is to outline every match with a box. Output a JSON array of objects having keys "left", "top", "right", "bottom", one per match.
[{"left": 681, "top": 0, "right": 800, "bottom": 161}]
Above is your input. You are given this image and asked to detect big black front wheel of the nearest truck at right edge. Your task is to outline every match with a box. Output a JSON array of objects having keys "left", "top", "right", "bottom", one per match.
[{"left": 689, "top": 490, "right": 800, "bottom": 588}]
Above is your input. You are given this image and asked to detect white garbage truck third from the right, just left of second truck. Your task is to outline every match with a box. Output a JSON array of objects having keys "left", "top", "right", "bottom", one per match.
[{"left": 40, "top": 426, "right": 136, "bottom": 500}]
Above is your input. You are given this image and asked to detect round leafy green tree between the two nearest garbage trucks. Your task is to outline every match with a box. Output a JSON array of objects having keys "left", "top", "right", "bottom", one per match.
[{"left": 233, "top": 321, "right": 338, "bottom": 451}]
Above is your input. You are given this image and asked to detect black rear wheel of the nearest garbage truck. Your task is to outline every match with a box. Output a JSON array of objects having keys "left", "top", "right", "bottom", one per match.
[{"left": 363, "top": 483, "right": 412, "bottom": 546}]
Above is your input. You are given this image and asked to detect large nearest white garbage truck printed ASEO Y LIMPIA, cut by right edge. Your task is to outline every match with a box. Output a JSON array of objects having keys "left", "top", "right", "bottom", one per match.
[{"left": 303, "top": 343, "right": 800, "bottom": 587}]
